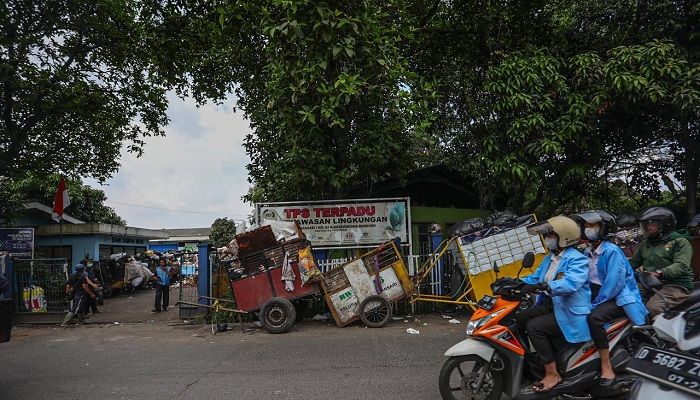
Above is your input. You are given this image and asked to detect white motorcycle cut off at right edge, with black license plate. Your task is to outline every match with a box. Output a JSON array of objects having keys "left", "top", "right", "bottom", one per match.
[{"left": 626, "top": 273, "right": 700, "bottom": 400}]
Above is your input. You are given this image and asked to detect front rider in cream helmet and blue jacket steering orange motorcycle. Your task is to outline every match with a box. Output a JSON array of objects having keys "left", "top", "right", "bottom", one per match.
[{"left": 516, "top": 215, "right": 591, "bottom": 392}]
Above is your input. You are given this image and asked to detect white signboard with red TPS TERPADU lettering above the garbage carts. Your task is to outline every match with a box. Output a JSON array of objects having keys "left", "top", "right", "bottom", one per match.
[{"left": 255, "top": 198, "right": 411, "bottom": 249}]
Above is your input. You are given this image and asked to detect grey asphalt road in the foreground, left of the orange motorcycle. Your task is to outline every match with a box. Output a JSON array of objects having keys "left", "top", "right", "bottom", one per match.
[{"left": 0, "top": 316, "right": 466, "bottom": 400}]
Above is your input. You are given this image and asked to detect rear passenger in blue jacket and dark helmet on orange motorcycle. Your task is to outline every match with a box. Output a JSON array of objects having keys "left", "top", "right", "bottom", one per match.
[{"left": 571, "top": 210, "right": 649, "bottom": 386}]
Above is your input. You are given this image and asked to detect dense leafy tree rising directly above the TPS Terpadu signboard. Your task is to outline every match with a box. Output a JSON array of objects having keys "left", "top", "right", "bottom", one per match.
[{"left": 144, "top": 0, "right": 433, "bottom": 201}]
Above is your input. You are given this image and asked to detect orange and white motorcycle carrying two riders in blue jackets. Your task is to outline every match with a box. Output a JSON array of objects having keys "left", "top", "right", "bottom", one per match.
[{"left": 439, "top": 253, "right": 653, "bottom": 400}]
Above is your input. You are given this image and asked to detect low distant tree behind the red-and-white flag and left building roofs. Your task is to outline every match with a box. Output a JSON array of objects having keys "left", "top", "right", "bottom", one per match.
[{"left": 9, "top": 174, "right": 126, "bottom": 225}]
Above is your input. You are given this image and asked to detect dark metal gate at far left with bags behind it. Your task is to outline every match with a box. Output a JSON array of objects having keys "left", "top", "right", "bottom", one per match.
[{"left": 13, "top": 258, "right": 68, "bottom": 313}]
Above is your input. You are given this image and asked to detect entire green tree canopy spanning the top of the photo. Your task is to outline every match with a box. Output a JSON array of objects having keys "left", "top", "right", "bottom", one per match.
[{"left": 0, "top": 0, "right": 700, "bottom": 220}]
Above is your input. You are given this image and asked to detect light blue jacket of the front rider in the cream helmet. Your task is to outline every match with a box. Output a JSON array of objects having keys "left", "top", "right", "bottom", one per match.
[{"left": 523, "top": 247, "right": 591, "bottom": 343}]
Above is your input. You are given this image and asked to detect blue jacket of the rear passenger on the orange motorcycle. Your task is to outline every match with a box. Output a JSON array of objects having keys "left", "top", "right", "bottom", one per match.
[{"left": 593, "top": 241, "right": 649, "bottom": 325}]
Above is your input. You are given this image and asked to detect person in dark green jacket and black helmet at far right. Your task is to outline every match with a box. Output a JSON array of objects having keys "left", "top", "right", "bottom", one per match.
[{"left": 630, "top": 207, "right": 693, "bottom": 318}]
